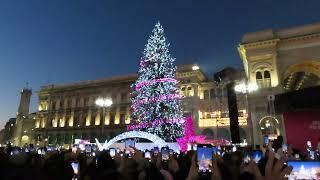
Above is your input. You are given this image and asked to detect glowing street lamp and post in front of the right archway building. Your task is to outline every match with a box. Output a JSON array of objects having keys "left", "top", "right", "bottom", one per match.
[{"left": 234, "top": 82, "right": 259, "bottom": 145}]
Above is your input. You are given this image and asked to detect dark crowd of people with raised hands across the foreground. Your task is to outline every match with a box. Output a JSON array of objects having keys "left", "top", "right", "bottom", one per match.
[{"left": 0, "top": 139, "right": 320, "bottom": 180}]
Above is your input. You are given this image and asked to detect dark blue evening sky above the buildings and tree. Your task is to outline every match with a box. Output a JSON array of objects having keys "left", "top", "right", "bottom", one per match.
[{"left": 0, "top": 0, "right": 320, "bottom": 127}]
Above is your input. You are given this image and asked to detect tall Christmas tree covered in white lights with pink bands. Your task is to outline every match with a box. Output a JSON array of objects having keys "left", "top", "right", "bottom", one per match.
[{"left": 131, "top": 22, "right": 183, "bottom": 141}]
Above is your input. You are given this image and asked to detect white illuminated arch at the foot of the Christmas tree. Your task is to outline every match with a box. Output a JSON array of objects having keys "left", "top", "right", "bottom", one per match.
[{"left": 96, "top": 131, "right": 167, "bottom": 150}]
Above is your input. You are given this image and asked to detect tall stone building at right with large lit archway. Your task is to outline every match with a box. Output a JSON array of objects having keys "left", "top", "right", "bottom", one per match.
[{"left": 238, "top": 23, "right": 320, "bottom": 144}]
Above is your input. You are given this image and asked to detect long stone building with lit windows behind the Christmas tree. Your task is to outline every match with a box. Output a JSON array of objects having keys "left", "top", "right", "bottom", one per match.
[{"left": 34, "top": 64, "right": 249, "bottom": 145}]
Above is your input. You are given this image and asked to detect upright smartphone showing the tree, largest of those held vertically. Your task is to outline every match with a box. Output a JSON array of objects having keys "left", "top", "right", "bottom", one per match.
[{"left": 197, "top": 144, "right": 213, "bottom": 174}]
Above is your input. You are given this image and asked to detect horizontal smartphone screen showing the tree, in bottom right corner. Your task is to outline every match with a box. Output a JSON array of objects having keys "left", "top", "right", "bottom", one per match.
[{"left": 287, "top": 161, "right": 320, "bottom": 180}]
